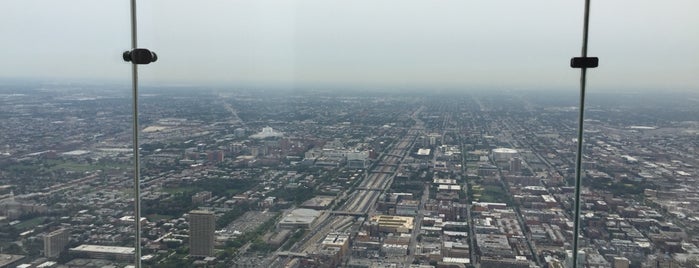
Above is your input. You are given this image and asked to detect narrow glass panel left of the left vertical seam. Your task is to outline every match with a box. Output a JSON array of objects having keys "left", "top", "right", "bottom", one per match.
[{"left": 0, "top": 0, "right": 134, "bottom": 267}]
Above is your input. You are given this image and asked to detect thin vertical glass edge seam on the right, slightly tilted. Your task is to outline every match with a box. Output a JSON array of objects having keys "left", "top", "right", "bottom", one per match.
[{"left": 573, "top": 0, "right": 590, "bottom": 267}]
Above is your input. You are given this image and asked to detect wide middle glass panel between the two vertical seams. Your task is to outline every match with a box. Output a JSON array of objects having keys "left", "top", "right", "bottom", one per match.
[{"left": 140, "top": 1, "right": 580, "bottom": 267}]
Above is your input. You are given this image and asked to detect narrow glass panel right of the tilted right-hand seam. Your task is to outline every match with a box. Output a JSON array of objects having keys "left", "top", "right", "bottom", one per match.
[{"left": 581, "top": 1, "right": 699, "bottom": 267}]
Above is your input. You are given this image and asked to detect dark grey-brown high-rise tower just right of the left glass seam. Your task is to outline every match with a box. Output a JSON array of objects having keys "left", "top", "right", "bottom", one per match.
[{"left": 189, "top": 210, "right": 216, "bottom": 256}]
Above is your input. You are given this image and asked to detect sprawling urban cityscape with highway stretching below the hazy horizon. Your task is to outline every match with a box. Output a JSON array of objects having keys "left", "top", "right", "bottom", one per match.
[{"left": 0, "top": 83, "right": 699, "bottom": 268}]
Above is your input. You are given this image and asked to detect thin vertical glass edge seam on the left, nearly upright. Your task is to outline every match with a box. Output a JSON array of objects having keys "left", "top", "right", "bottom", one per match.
[{"left": 131, "top": 0, "right": 141, "bottom": 268}]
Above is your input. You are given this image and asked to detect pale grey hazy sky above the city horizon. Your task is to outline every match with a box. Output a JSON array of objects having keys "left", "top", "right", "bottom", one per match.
[{"left": 0, "top": 0, "right": 699, "bottom": 90}]
